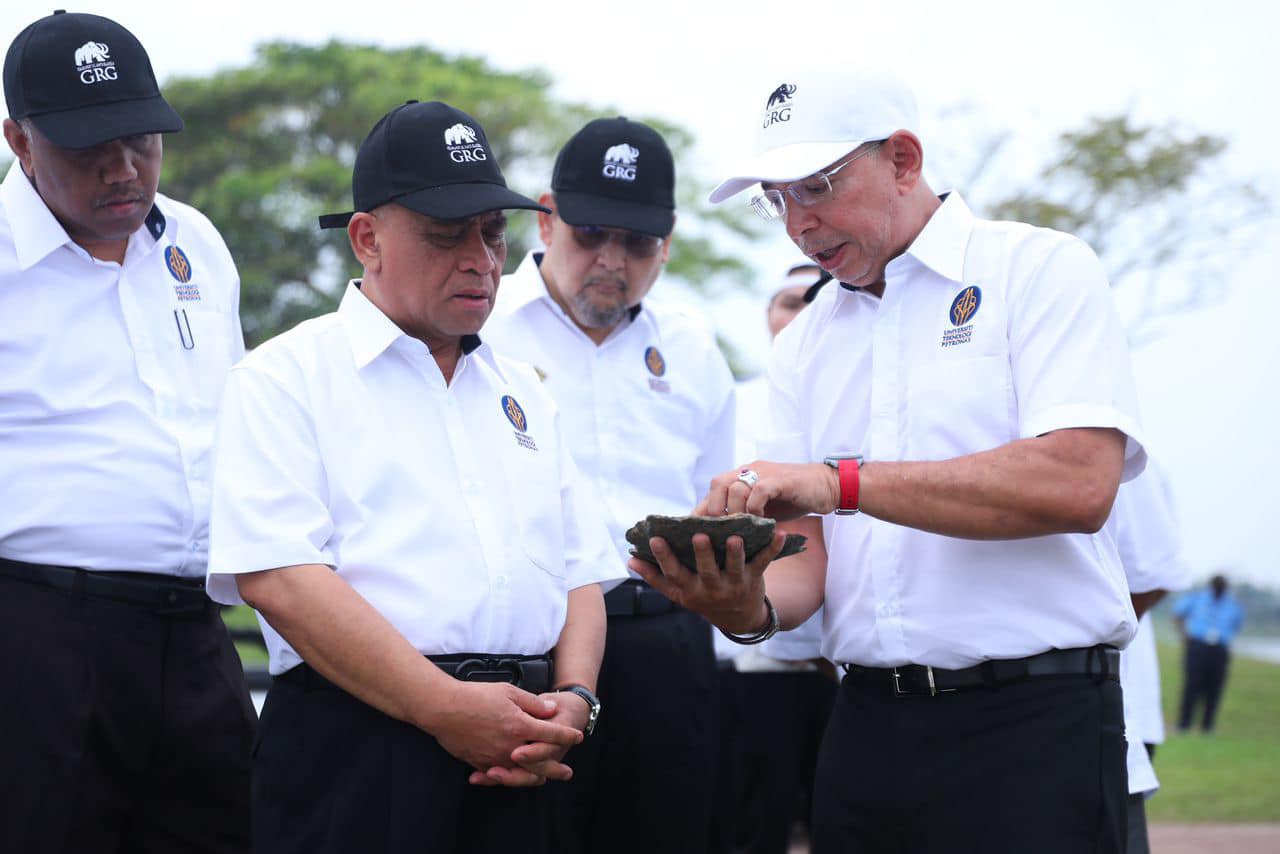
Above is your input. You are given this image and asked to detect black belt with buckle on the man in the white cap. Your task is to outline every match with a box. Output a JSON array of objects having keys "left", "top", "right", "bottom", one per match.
[{"left": 845, "top": 644, "right": 1120, "bottom": 697}]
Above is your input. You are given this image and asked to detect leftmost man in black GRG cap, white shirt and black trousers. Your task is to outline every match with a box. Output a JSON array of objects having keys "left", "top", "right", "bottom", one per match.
[{"left": 0, "top": 13, "right": 255, "bottom": 853}]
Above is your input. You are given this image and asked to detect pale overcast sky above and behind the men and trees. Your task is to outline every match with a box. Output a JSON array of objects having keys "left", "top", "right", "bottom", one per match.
[{"left": 10, "top": 0, "right": 1280, "bottom": 586}]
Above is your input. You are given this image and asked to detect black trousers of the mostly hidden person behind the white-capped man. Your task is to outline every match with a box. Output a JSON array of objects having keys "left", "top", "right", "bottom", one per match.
[{"left": 708, "top": 670, "right": 836, "bottom": 854}]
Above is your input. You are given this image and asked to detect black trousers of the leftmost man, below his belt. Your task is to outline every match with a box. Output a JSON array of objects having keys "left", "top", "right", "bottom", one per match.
[{"left": 0, "top": 577, "right": 256, "bottom": 854}]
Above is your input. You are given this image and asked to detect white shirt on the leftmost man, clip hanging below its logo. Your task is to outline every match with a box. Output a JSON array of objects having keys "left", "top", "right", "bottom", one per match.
[{"left": 0, "top": 161, "right": 244, "bottom": 577}]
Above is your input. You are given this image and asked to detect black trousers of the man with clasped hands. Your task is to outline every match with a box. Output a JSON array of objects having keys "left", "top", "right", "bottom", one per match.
[{"left": 253, "top": 679, "right": 559, "bottom": 854}]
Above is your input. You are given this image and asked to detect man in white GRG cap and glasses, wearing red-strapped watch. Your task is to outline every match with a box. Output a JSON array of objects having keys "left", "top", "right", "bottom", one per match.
[{"left": 631, "top": 69, "right": 1146, "bottom": 854}]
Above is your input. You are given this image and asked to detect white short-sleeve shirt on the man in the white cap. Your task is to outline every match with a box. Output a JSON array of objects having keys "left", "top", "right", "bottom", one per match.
[{"left": 762, "top": 193, "right": 1146, "bottom": 668}]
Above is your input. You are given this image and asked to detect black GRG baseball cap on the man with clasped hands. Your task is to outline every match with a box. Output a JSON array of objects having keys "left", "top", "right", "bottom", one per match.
[{"left": 320, "top": 101, "right": 550, "bottom": 228}]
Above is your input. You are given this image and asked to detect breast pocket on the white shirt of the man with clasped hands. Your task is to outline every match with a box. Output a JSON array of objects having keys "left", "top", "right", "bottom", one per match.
[{"left": 506, "top": 446, "right": 567, "bottom": 579}]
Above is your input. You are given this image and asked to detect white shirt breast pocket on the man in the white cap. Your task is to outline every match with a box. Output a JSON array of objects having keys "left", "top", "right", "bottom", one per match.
[{"left": 905, "top": 355, "right": 1018, "bottom": 460}]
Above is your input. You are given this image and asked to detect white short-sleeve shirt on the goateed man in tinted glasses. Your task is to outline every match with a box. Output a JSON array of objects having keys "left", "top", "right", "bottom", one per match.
[{"left": 484, "top": 252, "right": 733, "bottom": 573}]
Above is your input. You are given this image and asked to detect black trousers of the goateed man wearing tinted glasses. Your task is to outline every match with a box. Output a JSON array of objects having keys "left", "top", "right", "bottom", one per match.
[{"left": 556, "top": 609, "right": 719, "bottom": 854}]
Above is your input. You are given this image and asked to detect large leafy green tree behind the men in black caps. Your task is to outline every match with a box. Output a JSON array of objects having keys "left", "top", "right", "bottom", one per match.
[{"left": 161, "top": 41, "right": 749, "bottom": 346}]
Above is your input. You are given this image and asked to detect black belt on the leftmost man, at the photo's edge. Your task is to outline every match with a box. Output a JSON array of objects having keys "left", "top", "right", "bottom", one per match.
[{"left": 0, "top": 557, "right": 218, "bottom": 616}]
